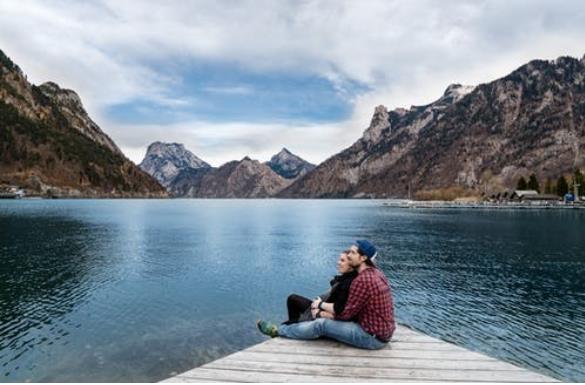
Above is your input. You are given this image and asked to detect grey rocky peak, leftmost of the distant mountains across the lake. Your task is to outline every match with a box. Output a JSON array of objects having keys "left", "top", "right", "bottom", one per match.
[{"left": 140, "top": 142, "right": 211, "bottom": 189}]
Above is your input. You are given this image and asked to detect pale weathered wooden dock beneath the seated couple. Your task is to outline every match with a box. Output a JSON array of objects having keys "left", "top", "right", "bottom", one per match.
[{"left": 162, "top": 325, "right": 558, "bottom": 382}]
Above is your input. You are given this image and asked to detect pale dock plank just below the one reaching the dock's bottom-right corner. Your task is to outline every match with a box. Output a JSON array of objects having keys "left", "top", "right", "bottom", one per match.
[{"left": 181, "top": 367, "right": 437, "bottom": 383}]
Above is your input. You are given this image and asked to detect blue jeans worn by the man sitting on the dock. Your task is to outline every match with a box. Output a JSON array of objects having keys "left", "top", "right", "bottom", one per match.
[{"left": 278, "top": 318, "right": 386, "bottom": 349}]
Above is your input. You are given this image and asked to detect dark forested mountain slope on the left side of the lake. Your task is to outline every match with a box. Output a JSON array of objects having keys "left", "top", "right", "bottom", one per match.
[{"left": 0, "top": 50, "right": 166, "bottom": 197}]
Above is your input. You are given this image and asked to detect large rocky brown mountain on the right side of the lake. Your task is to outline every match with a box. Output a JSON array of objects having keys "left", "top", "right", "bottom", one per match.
[{"left": 279, "top": 57, "right": 585, "bottom": 198}]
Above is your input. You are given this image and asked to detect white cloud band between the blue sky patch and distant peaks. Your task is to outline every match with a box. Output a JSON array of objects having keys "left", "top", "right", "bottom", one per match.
[{"left": 108, "top": 116, "right": 356, "bottom": 166}]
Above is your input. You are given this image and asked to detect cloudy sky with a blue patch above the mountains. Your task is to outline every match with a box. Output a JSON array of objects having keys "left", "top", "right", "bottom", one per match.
[{"left": 0, "top": 0, "right": 585, "bottom": 166}]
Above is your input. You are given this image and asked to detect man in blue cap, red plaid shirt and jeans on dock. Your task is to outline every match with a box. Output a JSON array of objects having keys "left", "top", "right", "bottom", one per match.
[{"left": 257, "top": 240, "right": 396, "bottom": 349}]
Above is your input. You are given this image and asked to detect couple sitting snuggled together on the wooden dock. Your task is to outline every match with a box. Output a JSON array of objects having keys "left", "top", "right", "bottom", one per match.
[{"left": 257, "top": 240, "right": 395, "bottom": 349}]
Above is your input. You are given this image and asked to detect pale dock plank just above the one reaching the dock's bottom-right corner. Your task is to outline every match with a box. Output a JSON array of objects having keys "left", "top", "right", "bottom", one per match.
[{"left": 224, "top": 351, "right": 524, "bottom": 371}]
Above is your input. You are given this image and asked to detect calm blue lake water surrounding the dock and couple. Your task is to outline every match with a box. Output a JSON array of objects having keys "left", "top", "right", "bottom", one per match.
[{"left": 0, "top": 200, "right": 585, "bottom": 382}]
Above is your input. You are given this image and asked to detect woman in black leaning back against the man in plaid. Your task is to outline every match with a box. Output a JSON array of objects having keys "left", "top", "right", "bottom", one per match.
[{"left": 283, "top": 250, "right": 357, "bottom": 325}]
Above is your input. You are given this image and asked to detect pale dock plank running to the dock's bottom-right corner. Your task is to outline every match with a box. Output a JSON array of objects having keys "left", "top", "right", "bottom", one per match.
[{"left": 204, "top": 359, "right": 549, "bottom": 382}]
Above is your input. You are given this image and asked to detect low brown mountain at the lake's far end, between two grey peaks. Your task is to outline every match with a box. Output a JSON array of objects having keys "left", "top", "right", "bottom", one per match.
[{"left": 170, "top": 157, "right": 290, "bottom": 198}]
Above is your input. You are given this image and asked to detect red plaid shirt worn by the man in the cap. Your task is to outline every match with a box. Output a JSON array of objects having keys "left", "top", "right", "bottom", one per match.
[{"left": 335, "top": 267, "right": 396, "bottom": 341}]
